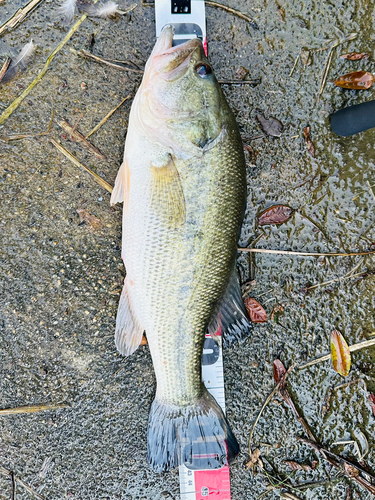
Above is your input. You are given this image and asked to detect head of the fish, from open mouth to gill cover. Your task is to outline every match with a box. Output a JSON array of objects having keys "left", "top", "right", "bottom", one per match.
[{"left": 139, "top": 26, "right": 227, "bottom": 155}]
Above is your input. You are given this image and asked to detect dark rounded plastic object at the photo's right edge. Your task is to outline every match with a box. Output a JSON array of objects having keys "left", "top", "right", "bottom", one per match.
[{"left": 331, "top": 100, "right": 375, "bottom": 137}]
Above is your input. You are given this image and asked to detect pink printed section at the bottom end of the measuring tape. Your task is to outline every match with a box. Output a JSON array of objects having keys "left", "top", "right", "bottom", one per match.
[{"left": 194, "top": 466, "right": 230, "bottom": 500}]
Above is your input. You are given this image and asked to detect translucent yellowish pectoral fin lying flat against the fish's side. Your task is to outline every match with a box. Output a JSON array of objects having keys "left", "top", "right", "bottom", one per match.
[{"left": 150, "top": 157, "right": 186, "bottom": 227}]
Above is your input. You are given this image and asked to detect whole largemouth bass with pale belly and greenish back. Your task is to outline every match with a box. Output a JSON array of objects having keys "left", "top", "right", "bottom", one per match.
[{"left": 111, "top": 26, "right": 246, "bottom": 471}]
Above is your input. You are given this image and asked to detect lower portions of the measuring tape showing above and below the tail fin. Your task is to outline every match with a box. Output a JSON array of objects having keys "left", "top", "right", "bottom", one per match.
[{"left": 179, "top": 334, "right": 231, "bottom": 500}]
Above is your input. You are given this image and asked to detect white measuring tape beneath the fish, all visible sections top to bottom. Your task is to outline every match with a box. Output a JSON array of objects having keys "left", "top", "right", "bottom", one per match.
[{"left": 155, "top": 0, "right": 231, "bottom": 500}]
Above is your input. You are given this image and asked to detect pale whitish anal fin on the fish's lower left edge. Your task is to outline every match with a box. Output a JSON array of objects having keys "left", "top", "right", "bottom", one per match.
[{"left": 115, "top": 278, "right": 144, "bottom": 356}]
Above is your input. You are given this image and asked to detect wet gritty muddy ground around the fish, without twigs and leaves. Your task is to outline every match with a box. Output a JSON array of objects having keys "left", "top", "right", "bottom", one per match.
[{"left": 0, "top": 0, "right": 375, "bottom": 500}]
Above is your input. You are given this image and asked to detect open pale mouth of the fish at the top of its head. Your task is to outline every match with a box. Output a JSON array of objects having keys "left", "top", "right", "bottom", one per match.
[{"left": 152, "top": 26, "right": 204, "bottom": 75}]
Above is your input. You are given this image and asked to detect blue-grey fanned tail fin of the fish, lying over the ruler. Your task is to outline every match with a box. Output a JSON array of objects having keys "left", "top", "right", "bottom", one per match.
[{"left": 147, "top": 387, "right": 239, "bottom": 472}]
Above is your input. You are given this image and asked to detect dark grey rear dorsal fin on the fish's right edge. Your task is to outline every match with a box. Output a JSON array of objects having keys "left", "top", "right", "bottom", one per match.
[{"left": 208, "top": 267, "right": 251, "bottom": 344}]
